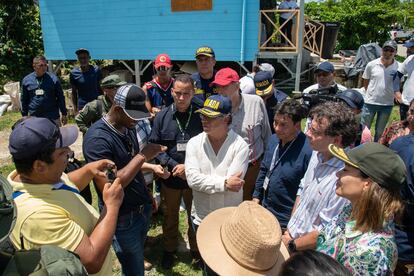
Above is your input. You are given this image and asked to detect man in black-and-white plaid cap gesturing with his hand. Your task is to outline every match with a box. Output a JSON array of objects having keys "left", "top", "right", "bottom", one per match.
[{"left": 83, "top": 84, "right": 166, "bottom": 275}]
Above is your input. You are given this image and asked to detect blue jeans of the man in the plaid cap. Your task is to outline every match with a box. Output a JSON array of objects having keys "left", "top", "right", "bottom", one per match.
[{"left": 112, "top": 203, "right": 152, "bottom": 276}]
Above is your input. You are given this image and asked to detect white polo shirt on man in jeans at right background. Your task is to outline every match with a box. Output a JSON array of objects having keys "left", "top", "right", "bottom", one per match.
[{"left": 362, "top": 58, "right": 398, "bottom": 106}]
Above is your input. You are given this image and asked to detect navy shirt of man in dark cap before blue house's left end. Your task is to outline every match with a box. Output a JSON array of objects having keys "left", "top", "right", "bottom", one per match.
[{"left": 69, "top": 65, "right": 102, "bottom": 108}]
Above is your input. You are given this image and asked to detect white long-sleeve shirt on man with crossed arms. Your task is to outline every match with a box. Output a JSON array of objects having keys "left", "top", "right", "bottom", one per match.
[{"left": 185, "top": 130, "right": 249, "bottom": 225}]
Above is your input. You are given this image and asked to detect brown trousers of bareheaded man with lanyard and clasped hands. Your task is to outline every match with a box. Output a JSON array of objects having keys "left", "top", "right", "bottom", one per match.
[{"left": 161, "top": 184, "right": 198, "bottom": 252}]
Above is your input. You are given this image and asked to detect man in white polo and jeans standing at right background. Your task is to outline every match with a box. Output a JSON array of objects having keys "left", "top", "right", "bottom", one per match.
[{"left": 361, "top": 40, "right": 398, "bottom": 142}]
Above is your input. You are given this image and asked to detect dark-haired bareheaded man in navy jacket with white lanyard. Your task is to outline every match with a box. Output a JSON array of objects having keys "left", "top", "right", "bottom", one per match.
[{"left": 253, "top": 100, "right": 312, "bottom": 229}]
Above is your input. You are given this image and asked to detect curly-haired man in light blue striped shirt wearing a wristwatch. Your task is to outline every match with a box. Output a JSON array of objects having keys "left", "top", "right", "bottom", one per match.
[{"left": 283, "top": 102, "right": 358, "bottom": 253}]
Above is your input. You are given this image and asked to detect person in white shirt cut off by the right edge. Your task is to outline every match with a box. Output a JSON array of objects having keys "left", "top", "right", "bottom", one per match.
[{"left": 395, "top": 38, "right": 414, "bottom": 121}]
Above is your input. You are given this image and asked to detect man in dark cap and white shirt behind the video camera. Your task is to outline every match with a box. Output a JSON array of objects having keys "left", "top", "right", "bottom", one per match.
[{"left": 303, "top": 61, "right": 346, "bottom": 93}]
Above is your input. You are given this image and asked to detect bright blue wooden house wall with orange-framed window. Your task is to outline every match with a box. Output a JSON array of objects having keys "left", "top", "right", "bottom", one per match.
[{"left": 39, "top": 0, "right": 259, "bottom": 62}]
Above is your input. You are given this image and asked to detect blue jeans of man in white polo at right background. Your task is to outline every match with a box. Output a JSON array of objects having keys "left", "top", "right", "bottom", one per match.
[{"left": 361, "top": 104, "right": 393, "bottom": 142}]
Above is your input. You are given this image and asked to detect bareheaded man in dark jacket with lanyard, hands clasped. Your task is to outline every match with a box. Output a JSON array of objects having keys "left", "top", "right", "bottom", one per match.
[{"left": 150, "top": 75, "right": 203, "bottom": 269}]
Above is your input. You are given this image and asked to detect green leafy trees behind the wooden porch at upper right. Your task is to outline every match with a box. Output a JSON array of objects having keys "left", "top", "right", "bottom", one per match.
[{"left": 305, "top": 0, "right": 406, "bottom": 49}]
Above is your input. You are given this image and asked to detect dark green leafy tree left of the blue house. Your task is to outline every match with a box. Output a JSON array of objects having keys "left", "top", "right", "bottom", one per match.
[{"left": 0, "top": 0, "right": 43, "bottom": 85}]
